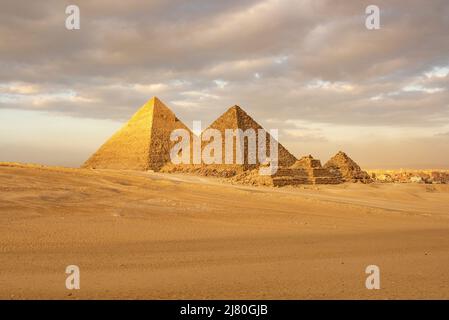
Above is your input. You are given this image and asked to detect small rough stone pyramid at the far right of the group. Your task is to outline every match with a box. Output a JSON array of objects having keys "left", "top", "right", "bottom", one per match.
[{"left": 324, "top": 151, "right": 372, "bottom": 183}]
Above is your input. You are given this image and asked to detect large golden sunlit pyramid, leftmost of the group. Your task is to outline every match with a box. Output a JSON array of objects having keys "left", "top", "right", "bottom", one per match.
[{"left": 83, "top": 97, "right": 192, "bottom": 170}]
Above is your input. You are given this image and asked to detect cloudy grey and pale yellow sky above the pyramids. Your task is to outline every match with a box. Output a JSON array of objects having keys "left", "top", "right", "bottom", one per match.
[{"left": 0, "top": 0, "right": 449, "bottom": 169}]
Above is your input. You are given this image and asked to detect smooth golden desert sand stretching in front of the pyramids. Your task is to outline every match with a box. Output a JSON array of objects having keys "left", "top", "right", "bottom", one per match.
[{"left": 0, "top": 163, "right": 449, "bottom": 299}]
